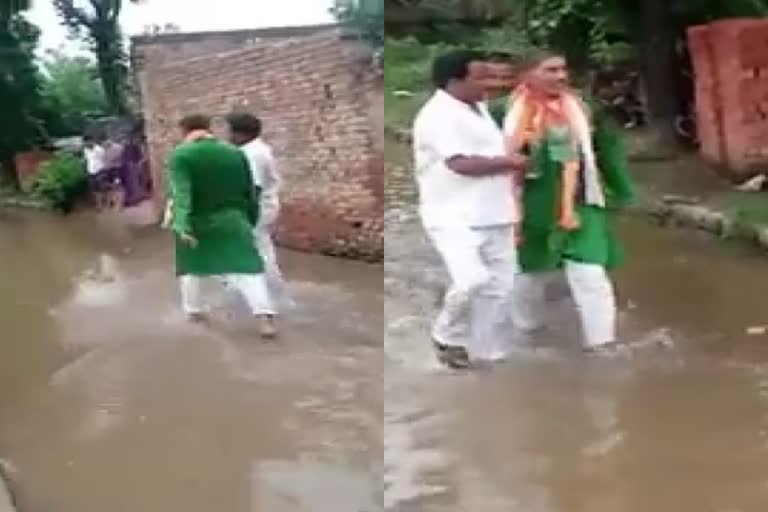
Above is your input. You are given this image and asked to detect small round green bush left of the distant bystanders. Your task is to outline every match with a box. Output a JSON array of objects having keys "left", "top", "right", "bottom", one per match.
[{"left": 33, "top": 153, "right": 88, "bottom": 213}]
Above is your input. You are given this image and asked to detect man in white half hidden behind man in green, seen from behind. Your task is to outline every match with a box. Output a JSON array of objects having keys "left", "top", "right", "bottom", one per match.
[{"left": 227, "top": 113, "right": 290, "bottom": 312}]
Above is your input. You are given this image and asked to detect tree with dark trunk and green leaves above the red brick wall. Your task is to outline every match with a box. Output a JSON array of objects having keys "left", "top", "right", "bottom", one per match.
[{"left": 523, "top": 0, "right": 768, "bottom": 142}]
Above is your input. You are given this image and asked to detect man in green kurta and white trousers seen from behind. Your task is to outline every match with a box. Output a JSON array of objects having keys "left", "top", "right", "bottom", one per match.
[{"left": 168, "top": 115, "right": 276, "bottom": 337}]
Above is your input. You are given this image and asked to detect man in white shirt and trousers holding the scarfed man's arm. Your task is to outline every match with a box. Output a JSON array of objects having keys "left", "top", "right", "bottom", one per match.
[{"left": 413, "top": 51, "right": 525, "bottom": 368}]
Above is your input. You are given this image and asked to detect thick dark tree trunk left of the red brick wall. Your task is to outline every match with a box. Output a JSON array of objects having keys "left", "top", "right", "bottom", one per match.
[{"left": 640, "top": 0, "right": 679, "bottom": 145}]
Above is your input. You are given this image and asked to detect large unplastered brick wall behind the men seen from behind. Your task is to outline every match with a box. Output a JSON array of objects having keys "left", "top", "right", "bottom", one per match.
[{"left": 134, "top": 29, "right": 384, "bottom": 261}]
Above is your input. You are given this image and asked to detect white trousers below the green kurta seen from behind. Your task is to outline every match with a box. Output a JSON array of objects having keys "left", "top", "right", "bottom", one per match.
[{"left": 179, "top": 274, "right": 275, "bottom": 316}]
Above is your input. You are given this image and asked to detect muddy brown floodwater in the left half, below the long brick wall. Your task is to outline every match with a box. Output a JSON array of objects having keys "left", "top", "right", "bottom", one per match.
[{"left": 0, "top": 212, "right": 383, "bottom": 512}]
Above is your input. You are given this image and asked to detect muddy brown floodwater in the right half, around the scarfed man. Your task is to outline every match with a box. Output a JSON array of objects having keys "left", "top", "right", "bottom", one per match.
[{"left": 384, "top": 206, "right": 768, "bottom": 512}]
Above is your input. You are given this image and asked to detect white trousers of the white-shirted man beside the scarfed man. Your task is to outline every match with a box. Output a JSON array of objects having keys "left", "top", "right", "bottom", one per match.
[{"left": 427, "top": 224, "right": 518, "bottom": 359}]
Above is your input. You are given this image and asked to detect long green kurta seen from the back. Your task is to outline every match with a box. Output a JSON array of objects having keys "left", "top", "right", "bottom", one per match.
[{"left": 168, "top": 138, "right": 264, "bottom": 276}]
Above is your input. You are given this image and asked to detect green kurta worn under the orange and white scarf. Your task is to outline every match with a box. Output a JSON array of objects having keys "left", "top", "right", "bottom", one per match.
[{"left": 492, "top": 101, "right": 634, "bottom": 272}]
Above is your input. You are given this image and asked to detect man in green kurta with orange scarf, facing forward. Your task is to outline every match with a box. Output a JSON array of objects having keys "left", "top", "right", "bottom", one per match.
[{"left": 504, "top": 53, "right": 633, "bottom": 350}]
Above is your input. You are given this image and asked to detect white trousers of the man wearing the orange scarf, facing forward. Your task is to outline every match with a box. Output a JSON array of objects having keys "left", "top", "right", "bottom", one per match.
[{"left": 514, "top": 261, "right": 616, "bottom": 347}]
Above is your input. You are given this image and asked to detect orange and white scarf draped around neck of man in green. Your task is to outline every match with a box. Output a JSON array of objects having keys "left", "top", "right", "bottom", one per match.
[{"left": 504, "top": 85, "right": 605, "bottom": 208}]
